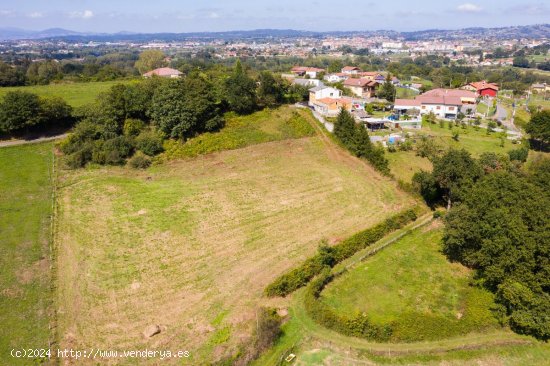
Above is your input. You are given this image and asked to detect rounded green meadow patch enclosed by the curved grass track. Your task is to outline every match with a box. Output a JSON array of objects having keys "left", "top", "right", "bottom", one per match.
[{"left": 322, "top": 223, "right": 497, "bottom": 340}]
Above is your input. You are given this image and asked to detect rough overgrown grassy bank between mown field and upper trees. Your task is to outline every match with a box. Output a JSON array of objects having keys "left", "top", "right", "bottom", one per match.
[{"left": 158, "top": 106, "right": 315, "bottom": 161}]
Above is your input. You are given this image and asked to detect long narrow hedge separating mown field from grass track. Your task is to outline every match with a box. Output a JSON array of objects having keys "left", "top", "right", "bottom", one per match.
[{"left": 265, "top": 209, "right": 416, "bottom": 296}]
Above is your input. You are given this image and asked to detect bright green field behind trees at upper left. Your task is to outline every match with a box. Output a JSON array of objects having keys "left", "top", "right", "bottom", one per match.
[{"left": 0, "top": 80, "right": 137, "bottom": 107}]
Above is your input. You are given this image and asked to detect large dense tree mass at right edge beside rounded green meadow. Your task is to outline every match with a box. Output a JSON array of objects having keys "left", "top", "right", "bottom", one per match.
[{"left": 443, "top": 171, "right": 550, "bottom": 340}]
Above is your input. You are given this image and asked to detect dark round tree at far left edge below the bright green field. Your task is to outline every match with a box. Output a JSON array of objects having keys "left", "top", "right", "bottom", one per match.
[{"left": 0, "top": 91, "right": 40, "bottom": 133}]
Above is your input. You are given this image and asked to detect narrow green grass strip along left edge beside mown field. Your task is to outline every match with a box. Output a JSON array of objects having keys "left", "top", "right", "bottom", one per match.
[{"left": 0, "top": 144, "right": 53, "bottom": 365}]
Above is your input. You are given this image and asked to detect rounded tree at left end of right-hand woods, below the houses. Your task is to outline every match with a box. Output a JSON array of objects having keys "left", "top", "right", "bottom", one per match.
[{"left": 433, "top": 149, "right": 482, "bottom": 209}]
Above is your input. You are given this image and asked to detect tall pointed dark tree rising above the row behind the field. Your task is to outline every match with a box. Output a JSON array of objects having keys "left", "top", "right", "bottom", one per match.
[{"left": 225, "top": 60, "right": 258, "bottom": 114}]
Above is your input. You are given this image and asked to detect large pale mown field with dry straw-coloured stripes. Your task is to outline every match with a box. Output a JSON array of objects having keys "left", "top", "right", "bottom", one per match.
[{"left": 56, "top": 108, "right": 414, "bottom": 364}]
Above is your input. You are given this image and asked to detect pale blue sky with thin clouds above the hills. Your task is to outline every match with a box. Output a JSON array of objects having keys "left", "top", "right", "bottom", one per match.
[{"left": 0, "top": 0, "right": 550, "bottom": 33}]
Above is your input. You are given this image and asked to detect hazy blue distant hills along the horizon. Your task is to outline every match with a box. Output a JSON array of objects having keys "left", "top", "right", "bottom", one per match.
[{"left": 0, "top": 24, "right": 550, "bottom": 42}]
